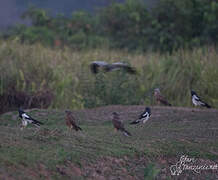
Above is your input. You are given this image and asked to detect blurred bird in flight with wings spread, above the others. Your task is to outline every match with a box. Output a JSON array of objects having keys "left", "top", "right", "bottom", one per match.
[{"left": 90, "top": 61, "right": 136, "bottom": 74}]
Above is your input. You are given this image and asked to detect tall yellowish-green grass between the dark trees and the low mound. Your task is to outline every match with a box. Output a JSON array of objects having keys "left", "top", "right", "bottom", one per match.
[{"left": 0, "top": 41, "right": 218, "bottom": 109}]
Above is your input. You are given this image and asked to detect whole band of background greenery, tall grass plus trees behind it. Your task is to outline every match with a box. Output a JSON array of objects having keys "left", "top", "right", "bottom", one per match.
[{"left": 0, "top": 0, "right": 218, "bottom": 112}]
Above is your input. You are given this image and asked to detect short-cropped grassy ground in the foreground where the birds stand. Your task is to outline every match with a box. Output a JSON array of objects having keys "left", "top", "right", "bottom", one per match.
[{"left": 0, "top": 105, "right": 218, "bottom": 180}]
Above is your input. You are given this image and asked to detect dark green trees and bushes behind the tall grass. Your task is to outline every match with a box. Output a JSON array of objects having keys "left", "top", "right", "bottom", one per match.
[{"left": 3, "top": 0, "right": 218, "bottom": 53}]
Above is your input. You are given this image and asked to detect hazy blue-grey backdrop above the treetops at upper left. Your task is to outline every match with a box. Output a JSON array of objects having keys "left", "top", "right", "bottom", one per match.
[{"left": 0, "top": 0, "right": 158, "bottom": 28}]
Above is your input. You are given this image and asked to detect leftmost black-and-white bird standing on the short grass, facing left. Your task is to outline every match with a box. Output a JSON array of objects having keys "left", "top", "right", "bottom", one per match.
[{"left": 18, "top": 109, "right": 43, "bottom": 128}]
